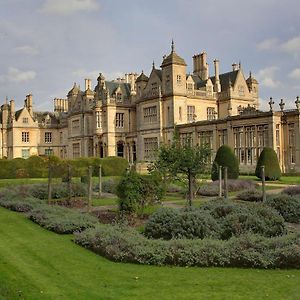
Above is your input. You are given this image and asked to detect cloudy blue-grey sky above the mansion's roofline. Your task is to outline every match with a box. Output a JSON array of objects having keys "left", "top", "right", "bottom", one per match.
[{"left": 0, "top": 0, "right": 300, "bottom": 110}]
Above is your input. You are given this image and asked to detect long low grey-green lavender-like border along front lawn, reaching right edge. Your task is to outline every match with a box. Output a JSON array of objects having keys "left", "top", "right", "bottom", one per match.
[{"left": 74, "top": 224, "right": 300, "bottom": 269}]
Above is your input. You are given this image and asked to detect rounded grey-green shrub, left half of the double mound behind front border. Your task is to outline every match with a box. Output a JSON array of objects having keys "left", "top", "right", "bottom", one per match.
[{"left": 145, "top": 208, "right": 220, "bottom": 239}]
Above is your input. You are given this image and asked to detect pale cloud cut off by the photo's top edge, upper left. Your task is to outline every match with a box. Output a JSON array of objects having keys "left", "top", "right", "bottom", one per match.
[{"left": 40, "top": 0, "right": 100, "bottom": 15}]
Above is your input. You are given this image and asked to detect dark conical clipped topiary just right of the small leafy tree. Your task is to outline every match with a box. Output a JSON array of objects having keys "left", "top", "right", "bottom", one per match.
[{"left": 211, "top": 145, "right": 239, "bottom": 181}]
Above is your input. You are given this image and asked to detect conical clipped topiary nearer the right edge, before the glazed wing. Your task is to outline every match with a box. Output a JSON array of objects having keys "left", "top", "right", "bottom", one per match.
[{"left": 255, "top": 147, "right": 281, "bottom": 180}]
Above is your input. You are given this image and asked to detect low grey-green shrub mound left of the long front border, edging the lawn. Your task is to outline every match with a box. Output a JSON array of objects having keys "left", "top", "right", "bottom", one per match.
[{"left": 27, "top": 205, "right": 97, "bottom": 233}]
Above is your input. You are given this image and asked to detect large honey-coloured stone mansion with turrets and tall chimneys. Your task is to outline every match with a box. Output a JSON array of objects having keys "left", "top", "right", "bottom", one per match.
[{"left": 0, "top": 42, "right": 300, "bottom": 173}]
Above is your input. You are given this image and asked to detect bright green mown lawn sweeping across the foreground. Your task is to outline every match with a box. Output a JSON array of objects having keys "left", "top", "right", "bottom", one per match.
[{"left": 0, "top": 208, "right": 300, "bottom": 299}]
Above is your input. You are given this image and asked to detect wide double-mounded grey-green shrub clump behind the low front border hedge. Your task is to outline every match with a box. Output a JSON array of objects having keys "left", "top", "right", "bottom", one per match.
[{"left": 145, "top": 200, "right": 287, "bottom": 239}]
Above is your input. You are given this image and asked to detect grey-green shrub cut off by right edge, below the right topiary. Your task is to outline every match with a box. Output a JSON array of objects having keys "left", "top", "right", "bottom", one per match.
[{"left": 266, "top": 194, "right": 300, "bottom": 223}]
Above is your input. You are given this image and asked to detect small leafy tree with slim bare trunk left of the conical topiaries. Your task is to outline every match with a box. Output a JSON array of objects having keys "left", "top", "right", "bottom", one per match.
[{"left": 153, "top": 133, "right": 211, "bottom": 206}]
